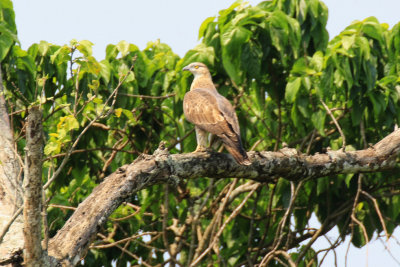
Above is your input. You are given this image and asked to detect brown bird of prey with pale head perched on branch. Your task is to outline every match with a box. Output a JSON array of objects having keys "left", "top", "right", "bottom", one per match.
[{"left": 183, "top": 62, "right": 251, "bottom": 165}]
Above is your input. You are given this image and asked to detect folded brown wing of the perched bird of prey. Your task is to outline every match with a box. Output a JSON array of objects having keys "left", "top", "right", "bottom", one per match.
[{"left": 183, "top": 89, "right": 238, "bottom": 139}]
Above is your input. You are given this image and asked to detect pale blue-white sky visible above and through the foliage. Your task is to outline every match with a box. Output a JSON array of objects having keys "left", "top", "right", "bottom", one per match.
[{"left": 13, "top": 0, "right": 400, "bottom": 267}]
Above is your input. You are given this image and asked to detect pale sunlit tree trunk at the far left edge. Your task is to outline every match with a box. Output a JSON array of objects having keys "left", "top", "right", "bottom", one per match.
[{"left": 0, "top": 66, "right": 24, "bottom": 264}]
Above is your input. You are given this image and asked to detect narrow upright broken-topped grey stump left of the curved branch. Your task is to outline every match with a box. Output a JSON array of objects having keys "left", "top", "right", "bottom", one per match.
[{"left": 24, "top": 107, "right": 45, "bottom": 266}]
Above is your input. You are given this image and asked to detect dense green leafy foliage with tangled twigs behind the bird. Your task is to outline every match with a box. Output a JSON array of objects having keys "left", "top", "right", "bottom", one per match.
[{"left": 0, "top": 0, "right": 400, "bottom": 266}]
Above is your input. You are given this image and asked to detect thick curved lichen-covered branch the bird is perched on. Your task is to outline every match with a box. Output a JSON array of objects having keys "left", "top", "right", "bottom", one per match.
[{"left": 49, "top": 130, "right": 400, "bottom": 266}]
